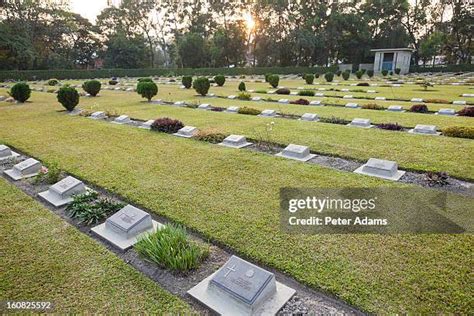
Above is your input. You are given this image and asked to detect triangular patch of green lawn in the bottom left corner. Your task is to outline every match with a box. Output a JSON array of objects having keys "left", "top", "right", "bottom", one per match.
[{"left": 0, "top": 179, "right": 191, "bottom": 314}]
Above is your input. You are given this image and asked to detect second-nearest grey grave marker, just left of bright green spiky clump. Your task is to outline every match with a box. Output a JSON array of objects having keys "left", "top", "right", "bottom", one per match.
[{"left": 91, "top": 204, "right": 164, "bottom": 251}]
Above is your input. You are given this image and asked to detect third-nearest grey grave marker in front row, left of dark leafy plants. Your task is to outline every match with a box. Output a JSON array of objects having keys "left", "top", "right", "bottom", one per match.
[{"left": 38, "top": 176, "right": 86, "bottom": 207}]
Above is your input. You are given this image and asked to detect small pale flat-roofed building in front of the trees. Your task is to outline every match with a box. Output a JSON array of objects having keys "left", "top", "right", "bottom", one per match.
[{"left": 370, "top": 48, "right": 413, "bottom": 74}]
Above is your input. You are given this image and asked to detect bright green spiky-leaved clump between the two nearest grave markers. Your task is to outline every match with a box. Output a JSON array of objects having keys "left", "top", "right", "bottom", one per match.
[{"left": 135, "top": 224, "right": 209, "bottom": 272}]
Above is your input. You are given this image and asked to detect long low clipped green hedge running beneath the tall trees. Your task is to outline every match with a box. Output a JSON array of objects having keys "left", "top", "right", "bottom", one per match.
[{"left": 0, "top": 67, "right": 336, "bottom": 81}]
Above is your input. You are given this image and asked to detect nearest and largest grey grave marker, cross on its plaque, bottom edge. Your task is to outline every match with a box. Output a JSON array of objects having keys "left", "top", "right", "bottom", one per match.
[{"left": 188, "top": 256, "right": 295, "bottom": 315}]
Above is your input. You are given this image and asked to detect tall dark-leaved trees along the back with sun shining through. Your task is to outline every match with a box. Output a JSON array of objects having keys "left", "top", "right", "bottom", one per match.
[{"left": 0, "top": 0, "right": 474, "bottom": 70}]
